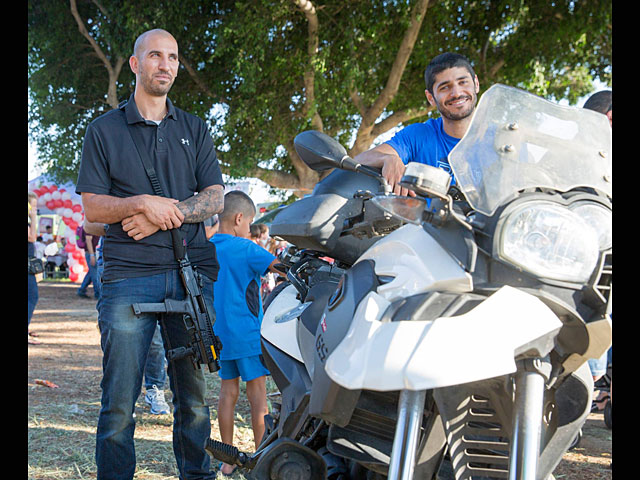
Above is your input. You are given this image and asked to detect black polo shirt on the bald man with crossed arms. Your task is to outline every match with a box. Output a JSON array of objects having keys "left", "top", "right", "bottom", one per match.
[{"left": 76, "top": 95, "right": 223, "bottom": 281}]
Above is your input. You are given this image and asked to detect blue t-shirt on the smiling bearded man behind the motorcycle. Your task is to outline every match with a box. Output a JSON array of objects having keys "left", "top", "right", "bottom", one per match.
[{"left": 385, "top": 117, "right": 460, "bottom": 183}]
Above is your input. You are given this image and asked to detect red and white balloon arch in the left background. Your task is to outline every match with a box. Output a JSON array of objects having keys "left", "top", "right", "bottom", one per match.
[{"left": 31, "top": 183, "right": 89, "bottom": 282}]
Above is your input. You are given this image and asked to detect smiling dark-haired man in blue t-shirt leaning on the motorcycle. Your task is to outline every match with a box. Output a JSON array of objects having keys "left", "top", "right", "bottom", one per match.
[{"left": 354, "top": 52, "right": 480, "bottom": 195}]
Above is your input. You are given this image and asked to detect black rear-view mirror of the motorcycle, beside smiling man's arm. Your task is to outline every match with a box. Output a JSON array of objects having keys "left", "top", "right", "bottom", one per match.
[{"left": 293, "top": 130, "right": 358, "bottom": 172}]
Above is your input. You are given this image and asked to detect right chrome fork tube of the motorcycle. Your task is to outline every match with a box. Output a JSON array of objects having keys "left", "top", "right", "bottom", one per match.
[{"left": 509, "top": 358, "right": 551, "bottom": 480}]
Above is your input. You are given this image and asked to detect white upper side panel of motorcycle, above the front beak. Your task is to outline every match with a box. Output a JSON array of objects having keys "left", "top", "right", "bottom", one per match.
[{"left": 358, "top": 224, "right": 473, "bottom": 302}]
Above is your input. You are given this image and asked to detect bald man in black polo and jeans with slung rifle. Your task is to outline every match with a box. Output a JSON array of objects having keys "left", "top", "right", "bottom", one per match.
[{"left": 76, "top": 29, "right": 224, "bottom": 480}]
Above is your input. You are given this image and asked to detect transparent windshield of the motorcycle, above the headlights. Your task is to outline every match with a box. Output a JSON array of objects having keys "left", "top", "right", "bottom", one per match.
[{"left": 449, "top": 84, "right": 612, "bottom": 215}]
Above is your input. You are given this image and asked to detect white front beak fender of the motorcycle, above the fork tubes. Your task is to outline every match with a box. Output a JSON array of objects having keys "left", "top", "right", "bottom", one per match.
[{"left": 325, "top": 284, "right": 562, "bottom": 391}]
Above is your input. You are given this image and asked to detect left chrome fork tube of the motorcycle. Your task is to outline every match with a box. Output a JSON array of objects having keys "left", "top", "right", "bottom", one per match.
[{"left": 387, "top": 390, "right": 426, "bottom": 480}]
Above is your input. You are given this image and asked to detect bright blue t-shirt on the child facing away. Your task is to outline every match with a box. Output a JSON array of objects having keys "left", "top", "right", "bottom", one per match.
[{"left": 209, "top": 233, "right": 276, "bottom": 360}]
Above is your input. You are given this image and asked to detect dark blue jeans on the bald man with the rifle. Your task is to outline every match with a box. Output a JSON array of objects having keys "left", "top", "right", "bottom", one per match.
[{"left": 96, "top": 270, "right": 215, "bottom": 480}]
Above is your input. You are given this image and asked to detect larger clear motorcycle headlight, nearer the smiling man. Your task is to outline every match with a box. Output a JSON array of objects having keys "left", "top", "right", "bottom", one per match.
[{"left": 497, "top": 201, "right": 599, "bottom": 282}]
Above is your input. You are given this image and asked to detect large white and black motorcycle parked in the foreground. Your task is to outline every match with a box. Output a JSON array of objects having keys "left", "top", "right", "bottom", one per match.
[{"left": 207, "top": 85, "right": 612, "bottom": 480}]
